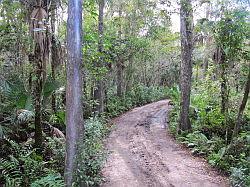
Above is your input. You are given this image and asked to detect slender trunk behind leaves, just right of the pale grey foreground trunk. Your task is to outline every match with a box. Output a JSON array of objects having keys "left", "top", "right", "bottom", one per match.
[{"left": 94, "top": 0, "right": 105, "bottom": 113}]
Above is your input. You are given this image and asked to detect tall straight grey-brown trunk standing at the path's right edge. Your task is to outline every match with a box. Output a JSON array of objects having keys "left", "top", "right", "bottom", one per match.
[{"left": 179, "top": 0, "right": 193, "bottom": 131}]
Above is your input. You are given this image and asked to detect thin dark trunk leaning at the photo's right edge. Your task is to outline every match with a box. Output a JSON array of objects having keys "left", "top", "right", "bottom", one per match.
[{"left": 233, "top": 67, "right": 250, "bottom": 137}]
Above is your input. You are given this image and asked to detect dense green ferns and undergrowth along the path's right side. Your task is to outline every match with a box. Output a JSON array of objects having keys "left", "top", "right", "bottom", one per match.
[{"left": 169, "top": 82, "right": 250, "bottom": 187}]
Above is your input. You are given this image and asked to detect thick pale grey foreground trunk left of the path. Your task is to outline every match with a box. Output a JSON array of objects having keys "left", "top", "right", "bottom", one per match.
[{"left": 65, "top": 0, "right": 84, "bottom": 187}]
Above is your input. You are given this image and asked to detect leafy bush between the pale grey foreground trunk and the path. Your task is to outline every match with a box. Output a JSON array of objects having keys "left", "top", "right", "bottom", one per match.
[{"left": 75, "top": 118, "right": 108, "bottom": 186}]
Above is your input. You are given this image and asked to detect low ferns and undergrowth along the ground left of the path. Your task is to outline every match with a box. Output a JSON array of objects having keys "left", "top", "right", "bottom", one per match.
[{"left": 0, "top": 83, "right": 167, "bottom": 187}]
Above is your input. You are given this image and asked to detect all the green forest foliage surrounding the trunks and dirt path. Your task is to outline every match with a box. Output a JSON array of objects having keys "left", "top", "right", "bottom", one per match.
[{"left": 0, "top": 0, "right": 250, "bottom": 187}]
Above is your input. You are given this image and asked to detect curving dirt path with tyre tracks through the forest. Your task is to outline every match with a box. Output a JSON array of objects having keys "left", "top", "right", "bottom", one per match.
[{"left": 101, "top": 100, "right": 228, "bottom": 187}]
